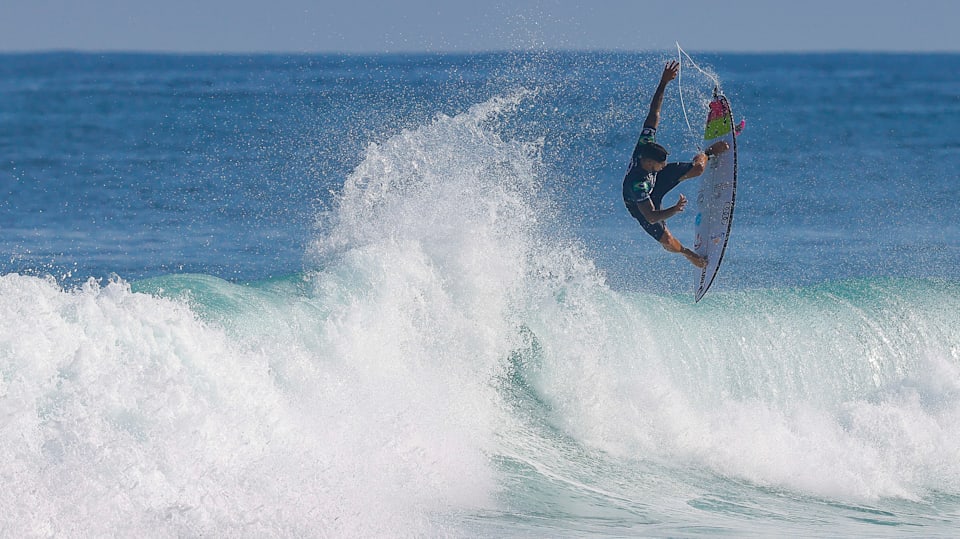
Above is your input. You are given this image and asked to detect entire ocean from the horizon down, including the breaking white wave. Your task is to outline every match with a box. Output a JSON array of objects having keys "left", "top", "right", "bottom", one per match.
[{"left": 0, "top": 51, "right": 960, "bottom": 537}]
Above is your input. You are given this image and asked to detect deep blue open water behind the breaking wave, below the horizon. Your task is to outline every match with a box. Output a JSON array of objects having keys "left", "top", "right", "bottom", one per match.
[{"left": 0, "top": 53, "right": 960, "bottom": 289}]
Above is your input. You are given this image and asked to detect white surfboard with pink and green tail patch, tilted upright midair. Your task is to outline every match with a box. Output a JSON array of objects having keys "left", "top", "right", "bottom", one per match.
[{"left": 693, "top": 88, "right": 737, "bottom": 302}]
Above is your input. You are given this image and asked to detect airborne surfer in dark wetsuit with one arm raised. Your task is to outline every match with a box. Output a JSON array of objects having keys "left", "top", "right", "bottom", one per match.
[{"left": 623, "top": 60, "right": 730, "bottom": 268}]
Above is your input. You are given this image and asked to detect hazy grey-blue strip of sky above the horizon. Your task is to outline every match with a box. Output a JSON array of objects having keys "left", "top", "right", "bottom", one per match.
[{"left": 0, "top": 0, "right": 960, "bottom": 53}]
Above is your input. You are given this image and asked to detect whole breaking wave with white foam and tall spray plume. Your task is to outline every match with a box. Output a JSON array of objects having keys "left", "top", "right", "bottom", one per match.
[{"left": 0, "top": 84, "right": 960, "bottom": 537}]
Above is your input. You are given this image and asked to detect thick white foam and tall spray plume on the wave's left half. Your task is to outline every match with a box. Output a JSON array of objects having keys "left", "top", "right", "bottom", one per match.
[{"left": 0, "top": 96, "right": 568, "bottom": 536}]
